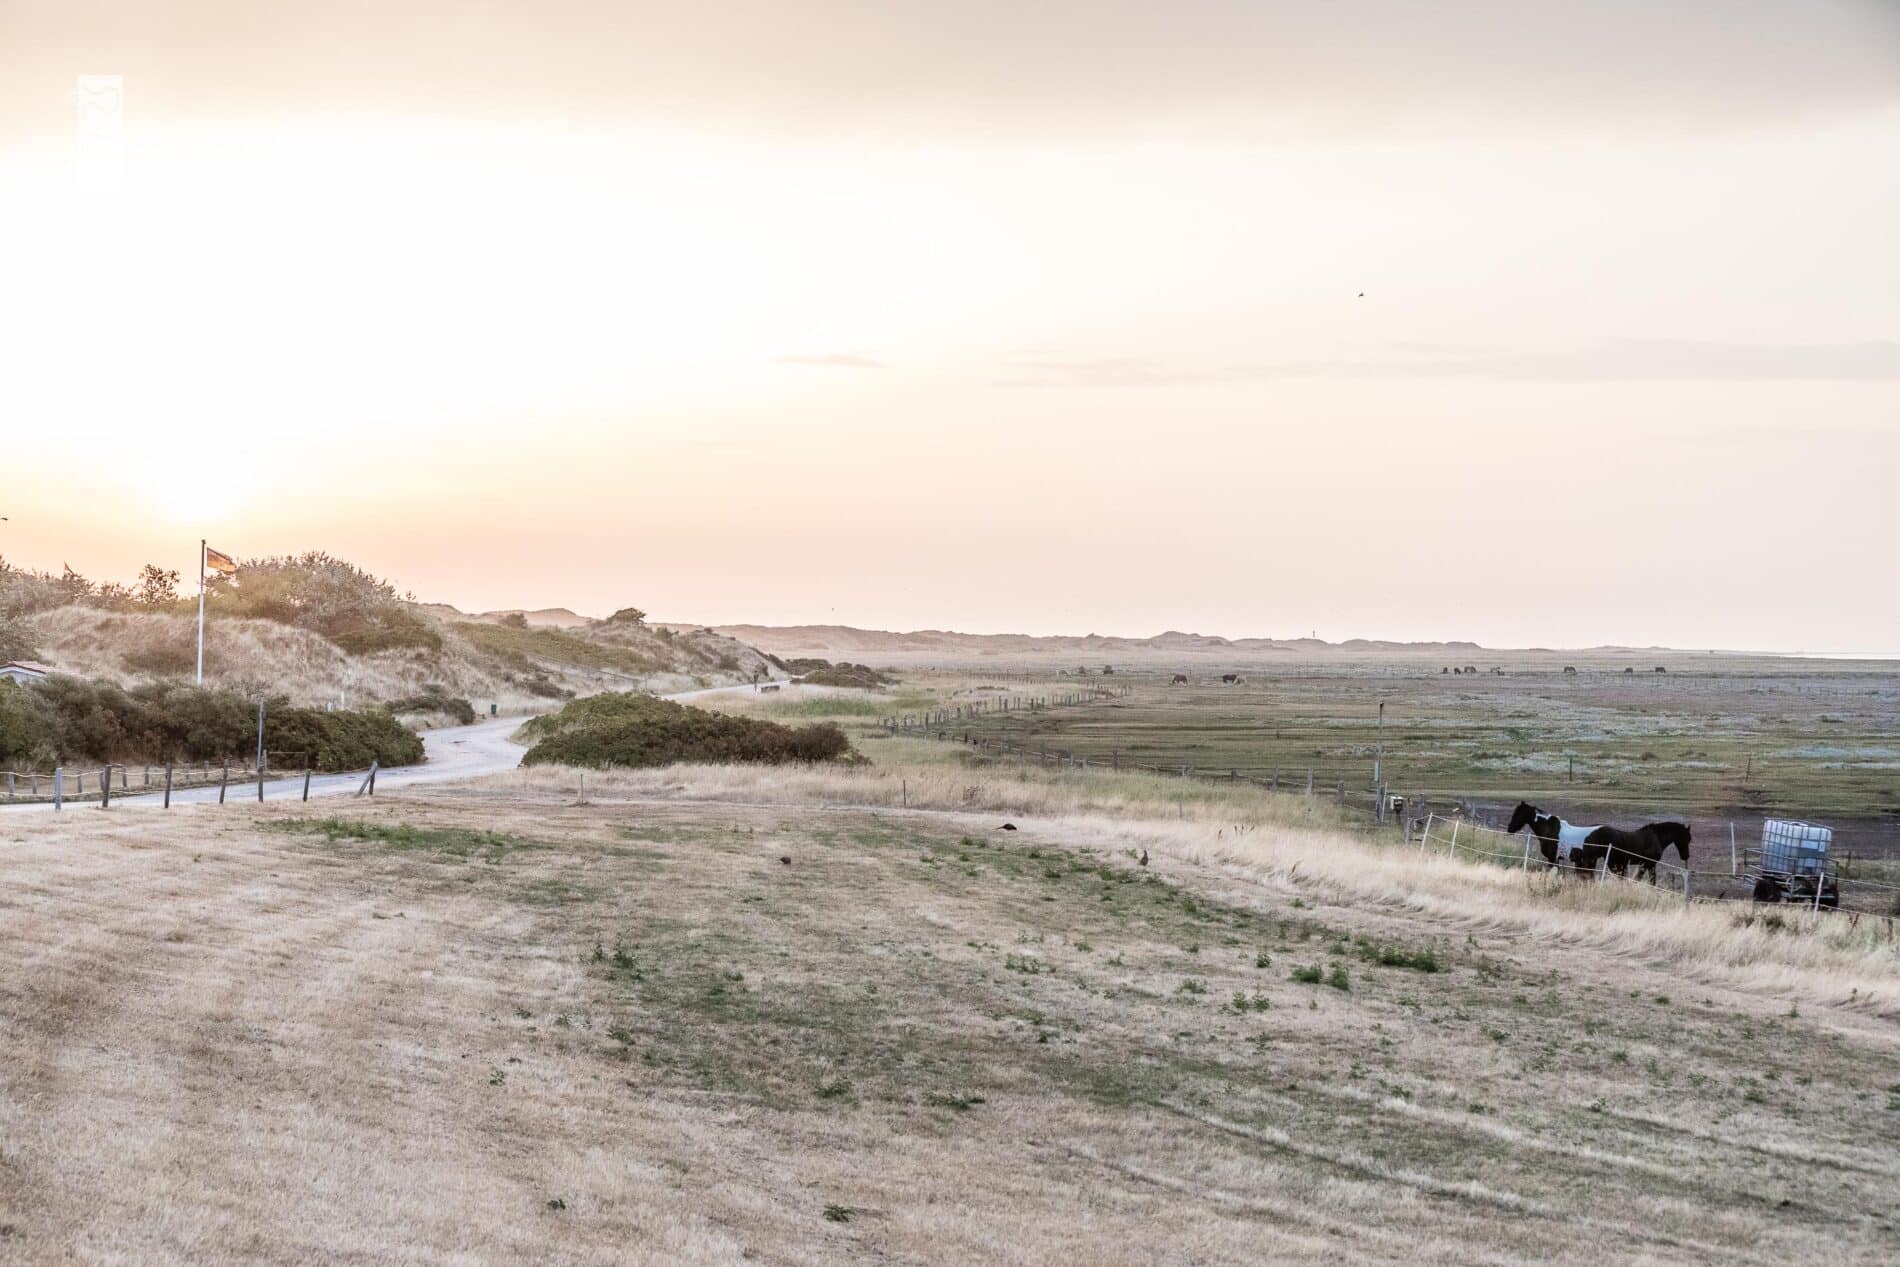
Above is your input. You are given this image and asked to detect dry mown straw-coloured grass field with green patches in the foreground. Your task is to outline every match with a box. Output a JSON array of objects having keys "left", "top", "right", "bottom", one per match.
[{"left": 0, "top": 741, "right": 1900, "bottom": 1265}]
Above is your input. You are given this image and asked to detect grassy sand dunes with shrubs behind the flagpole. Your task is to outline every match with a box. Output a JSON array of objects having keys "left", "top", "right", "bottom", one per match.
[{"left": 0, "top": 551, "right": 768, "bottom": 720}]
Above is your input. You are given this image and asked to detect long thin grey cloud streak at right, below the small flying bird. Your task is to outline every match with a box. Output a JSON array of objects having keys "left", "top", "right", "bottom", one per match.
[{"left": 998, "top": 338, "right": 1900, "bottom": 388}]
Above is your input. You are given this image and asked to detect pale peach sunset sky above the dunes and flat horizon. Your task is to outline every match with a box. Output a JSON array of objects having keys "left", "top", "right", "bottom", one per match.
[{"left": 0, "top": 0, "right": 1900, "bottom": 653}]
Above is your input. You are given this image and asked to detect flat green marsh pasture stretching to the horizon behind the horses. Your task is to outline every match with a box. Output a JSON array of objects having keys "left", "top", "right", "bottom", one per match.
[{"left": 893, "top": 657, "right": 1900, "bottom": 859}]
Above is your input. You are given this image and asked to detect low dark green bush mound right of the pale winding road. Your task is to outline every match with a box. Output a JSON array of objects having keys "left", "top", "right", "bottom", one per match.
[{"left": 523, "top": 693, "right": 851, "bottom": 769}]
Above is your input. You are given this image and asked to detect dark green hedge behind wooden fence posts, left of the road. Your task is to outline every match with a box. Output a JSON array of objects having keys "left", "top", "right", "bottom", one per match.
[{"left": 0, "top": 674, "right": 422, "bottom": 769}]
